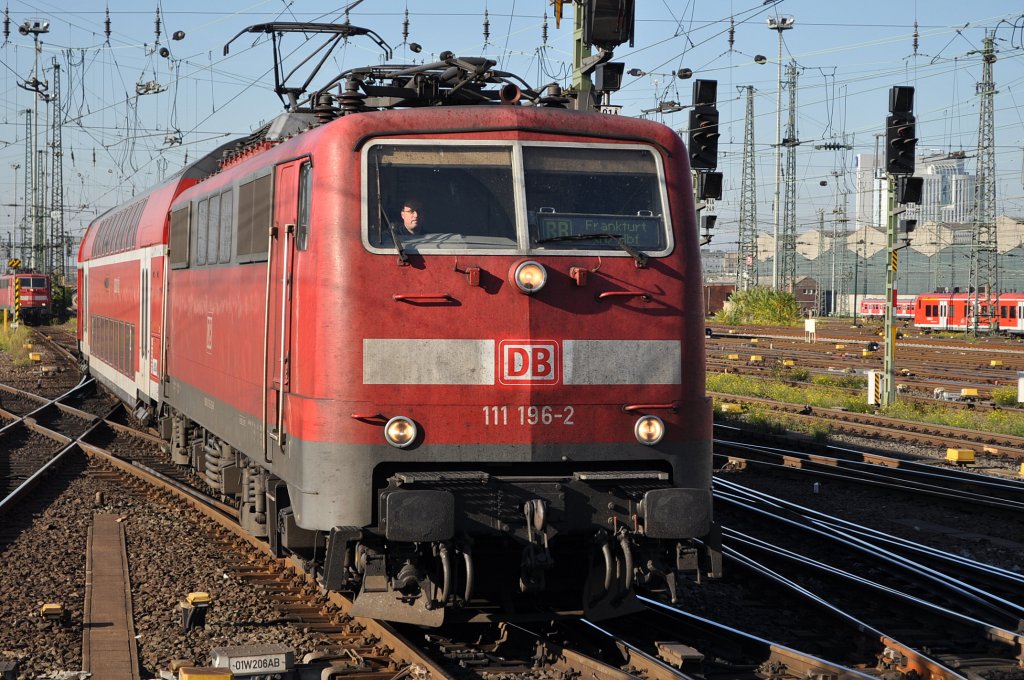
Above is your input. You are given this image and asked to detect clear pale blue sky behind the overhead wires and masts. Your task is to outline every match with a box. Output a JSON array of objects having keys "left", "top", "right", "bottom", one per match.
[{"left": 0, "top": 0, "right": 1024, "bottom": 252}]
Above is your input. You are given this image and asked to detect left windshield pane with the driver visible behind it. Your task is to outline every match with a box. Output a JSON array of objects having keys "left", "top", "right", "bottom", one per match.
[{"left": 367, "top": 144, "right": 516, "bottom": 253}]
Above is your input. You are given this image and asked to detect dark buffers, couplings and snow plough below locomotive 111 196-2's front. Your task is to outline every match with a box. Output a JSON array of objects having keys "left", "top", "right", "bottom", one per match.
[{"left": 324, "top": 470, "right": 716, "bottom": 626}]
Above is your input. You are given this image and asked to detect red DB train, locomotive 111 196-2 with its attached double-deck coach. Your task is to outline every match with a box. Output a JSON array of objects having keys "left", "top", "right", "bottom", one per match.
[{"left": 79, "top": 25, "right": 720, "bottom": 626}]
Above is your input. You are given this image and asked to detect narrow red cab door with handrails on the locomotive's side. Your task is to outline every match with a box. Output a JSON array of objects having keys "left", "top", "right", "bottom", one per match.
[{"left": 266, "top": 161, "right": 302, "bottom": 454}]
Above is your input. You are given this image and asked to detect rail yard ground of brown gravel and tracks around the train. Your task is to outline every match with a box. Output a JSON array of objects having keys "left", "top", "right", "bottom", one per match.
[{"left": 0, "top": 326, "right": 1024, "bottom": 679}]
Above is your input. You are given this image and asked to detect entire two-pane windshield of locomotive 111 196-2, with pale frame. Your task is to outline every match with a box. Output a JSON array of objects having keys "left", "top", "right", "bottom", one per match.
[{"left": 366, "top": 142, "right": 671, "bottom": 258}]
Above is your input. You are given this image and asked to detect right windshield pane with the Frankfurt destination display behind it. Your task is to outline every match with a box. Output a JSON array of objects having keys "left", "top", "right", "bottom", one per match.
[{"left": 523, "top": 146, "right": 669, "bottom": 252}]
